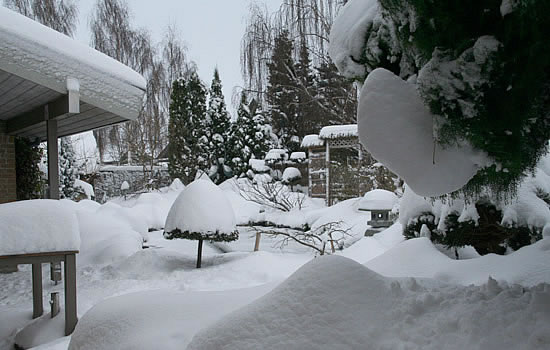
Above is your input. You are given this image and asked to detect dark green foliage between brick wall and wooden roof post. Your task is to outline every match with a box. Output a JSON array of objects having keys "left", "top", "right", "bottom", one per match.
[{"left": 15, "top": 137, "right": 45, "bottom": 200}]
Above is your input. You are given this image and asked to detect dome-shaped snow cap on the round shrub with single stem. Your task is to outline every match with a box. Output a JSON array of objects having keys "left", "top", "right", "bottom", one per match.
[{"left": 164, "top": 179, "right": 236, "bottom": 234}]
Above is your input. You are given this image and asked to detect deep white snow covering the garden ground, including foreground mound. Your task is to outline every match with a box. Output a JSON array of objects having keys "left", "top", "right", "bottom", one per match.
[{"left": 0, "top": 184, "right": 550, "bottom": 350}]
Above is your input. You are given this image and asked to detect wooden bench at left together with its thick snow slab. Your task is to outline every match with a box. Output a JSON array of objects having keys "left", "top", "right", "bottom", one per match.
[{"left": 0, "top": 200, "right": 80, "bottom": 335}]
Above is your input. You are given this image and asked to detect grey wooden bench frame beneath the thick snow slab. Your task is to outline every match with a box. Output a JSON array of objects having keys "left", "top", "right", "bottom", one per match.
[{"left": 0, "top": 250, "right": 78, "bottom": 335}]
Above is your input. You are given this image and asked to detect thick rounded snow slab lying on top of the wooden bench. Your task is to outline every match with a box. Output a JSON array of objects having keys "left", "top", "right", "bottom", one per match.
[{"left": 0, "top": 199, "right": 80, "bottom": 255}]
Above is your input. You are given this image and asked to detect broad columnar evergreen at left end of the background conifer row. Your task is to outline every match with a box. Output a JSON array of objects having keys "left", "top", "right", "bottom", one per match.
[{"left": 168, "top": 72, "right": 209, "bottom": 184}]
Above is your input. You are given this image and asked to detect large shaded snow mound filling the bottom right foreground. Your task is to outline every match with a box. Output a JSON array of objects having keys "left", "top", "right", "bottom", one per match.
[{"left": 187, "top": 254, "right": 550, "bottom": 350}]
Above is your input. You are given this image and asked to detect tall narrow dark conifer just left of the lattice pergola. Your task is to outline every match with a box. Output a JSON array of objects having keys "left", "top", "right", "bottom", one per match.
[{"left": 267, "top": 30, "right": 302, "bottom": 151}]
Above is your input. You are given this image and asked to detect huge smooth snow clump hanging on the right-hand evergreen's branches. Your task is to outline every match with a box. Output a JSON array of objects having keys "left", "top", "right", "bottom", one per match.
[{"left": 357, "top": 68, "right": 488, "bottom": 196}]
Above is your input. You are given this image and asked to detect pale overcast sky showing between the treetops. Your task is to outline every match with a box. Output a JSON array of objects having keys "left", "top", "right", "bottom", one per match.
[{"left": 76, "top": 0, "right": 282, "bottom": 116}]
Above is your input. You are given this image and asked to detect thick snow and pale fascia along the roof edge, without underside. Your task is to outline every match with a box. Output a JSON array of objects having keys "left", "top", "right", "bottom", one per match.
[{"left": 0, "top": 6, "right": 146, "bottom": 119}]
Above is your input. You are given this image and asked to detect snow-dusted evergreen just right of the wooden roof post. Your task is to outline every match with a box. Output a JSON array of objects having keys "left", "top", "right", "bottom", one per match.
[{"left": 59, "top": 137, "right": 78, "bottom": 199}]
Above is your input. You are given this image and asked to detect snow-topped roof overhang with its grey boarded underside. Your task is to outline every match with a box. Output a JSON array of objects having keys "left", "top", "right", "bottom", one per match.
[{"left": 0, "top": 7, "right": 146, "bottom": 140}]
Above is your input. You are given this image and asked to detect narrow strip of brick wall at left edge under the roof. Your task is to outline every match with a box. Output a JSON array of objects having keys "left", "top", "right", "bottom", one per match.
[{"left": 0, "top": 121, "right": 17, "bottom": 203}]
